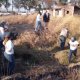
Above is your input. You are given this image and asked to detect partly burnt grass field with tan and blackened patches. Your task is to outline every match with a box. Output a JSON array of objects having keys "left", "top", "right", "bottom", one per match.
[{"left": 0, "top": 14, "right": 80, "bottom": 80}]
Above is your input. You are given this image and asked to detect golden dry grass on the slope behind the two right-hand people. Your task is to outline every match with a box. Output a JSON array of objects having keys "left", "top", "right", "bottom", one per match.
[{"left": 49, "top": 16, "right": 80, "bottom": 35}]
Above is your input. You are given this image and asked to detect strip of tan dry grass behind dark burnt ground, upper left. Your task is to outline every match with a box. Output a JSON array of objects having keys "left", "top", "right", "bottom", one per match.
[{"left": 0, "top": 14, "right": 36, "bottom": 24}]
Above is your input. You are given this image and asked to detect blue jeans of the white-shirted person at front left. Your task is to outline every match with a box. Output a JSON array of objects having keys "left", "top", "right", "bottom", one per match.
[{"left": 4, "top": 53, "right": 15, "bottom": 75}]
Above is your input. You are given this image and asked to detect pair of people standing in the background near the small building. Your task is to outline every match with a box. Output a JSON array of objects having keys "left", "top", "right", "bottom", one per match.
[{"left": 35, "top": 10, "right": 50, "bottom": 33}]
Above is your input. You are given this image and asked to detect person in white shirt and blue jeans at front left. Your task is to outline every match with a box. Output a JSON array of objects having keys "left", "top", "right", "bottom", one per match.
[{"left": 3, "top": 34, "right": 15, "bottom": 75}]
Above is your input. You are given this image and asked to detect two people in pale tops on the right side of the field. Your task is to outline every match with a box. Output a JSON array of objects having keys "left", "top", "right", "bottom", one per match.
[{"left": 59, "top": 27, "right": 79, "bottom": 63}]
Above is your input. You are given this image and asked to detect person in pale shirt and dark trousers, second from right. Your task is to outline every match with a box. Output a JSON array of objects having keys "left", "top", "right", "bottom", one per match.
[{"left": 59, "top": 27, "right": 69, "bottom": 50}]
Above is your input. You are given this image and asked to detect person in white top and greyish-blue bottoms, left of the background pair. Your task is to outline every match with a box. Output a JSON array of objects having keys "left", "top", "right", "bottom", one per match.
[{"left": 35, "top": 12, "right": 42, "bottom": 32}]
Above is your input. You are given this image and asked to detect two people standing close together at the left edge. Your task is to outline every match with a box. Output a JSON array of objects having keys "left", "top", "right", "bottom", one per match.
[{"left": 0, "top": 21, "right": 15, "bottom": 75}]
